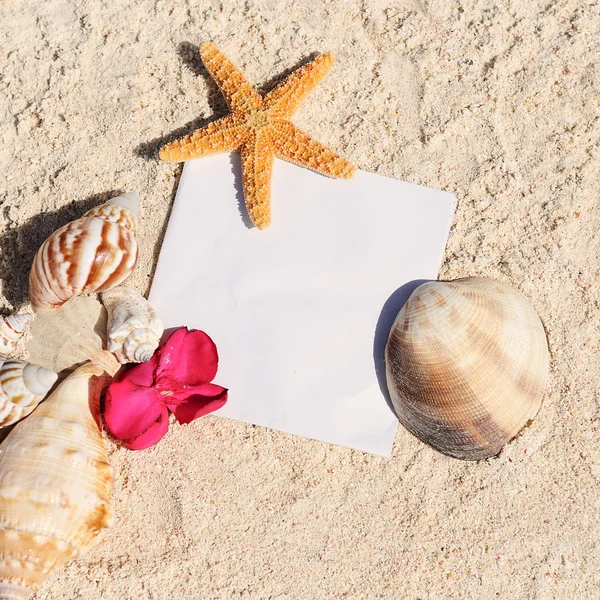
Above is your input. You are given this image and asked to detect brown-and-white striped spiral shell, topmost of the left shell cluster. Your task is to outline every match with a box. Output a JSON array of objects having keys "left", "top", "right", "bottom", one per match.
[{"left": 29, "top": 193, "right": 138, "bottom": 312}]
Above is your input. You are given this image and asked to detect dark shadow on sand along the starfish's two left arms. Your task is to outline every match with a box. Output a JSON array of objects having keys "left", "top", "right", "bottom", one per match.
[{"left": 134, "top": 42, "right": 229, "bottom": 160}]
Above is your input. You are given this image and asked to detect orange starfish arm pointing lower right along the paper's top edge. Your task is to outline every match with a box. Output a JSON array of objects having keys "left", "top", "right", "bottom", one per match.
[{"left": 272, "top": 121, "right": 356, "bottom": 179}]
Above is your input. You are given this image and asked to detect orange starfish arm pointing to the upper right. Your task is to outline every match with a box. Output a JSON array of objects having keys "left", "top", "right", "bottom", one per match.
[{"left": 264, "top": 52, "right": 334, "bottom": 119}]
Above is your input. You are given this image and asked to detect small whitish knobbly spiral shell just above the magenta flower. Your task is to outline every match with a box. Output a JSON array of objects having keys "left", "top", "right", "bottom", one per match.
[{"left": 101, "top": 286, "right": 164, "bottom": 364}]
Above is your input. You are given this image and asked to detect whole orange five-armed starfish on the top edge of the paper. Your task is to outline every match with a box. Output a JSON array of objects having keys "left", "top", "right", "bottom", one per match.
[{"left": 159, "top": 42, "right": 356, "bottom": 229}]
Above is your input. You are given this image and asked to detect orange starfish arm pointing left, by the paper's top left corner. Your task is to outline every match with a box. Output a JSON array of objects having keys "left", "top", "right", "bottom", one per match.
[{"left": 158, "top": 115, "right": 248, "bottom": 162}]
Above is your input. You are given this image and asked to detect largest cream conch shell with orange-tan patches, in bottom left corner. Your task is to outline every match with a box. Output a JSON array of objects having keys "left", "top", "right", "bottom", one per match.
[{"left": 0, "top": 363, "right": 113, "bottom": 600}]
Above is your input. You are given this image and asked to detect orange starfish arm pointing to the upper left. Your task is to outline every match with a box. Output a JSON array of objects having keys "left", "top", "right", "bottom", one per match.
[{"left": 200, "top": 42, "right": 262, "bottom": 112}]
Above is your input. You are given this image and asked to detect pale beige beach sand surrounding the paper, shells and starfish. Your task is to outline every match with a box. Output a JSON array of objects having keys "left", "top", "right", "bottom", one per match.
[{"left": 0, "top": 0, "right": 600, "bottom": 600}]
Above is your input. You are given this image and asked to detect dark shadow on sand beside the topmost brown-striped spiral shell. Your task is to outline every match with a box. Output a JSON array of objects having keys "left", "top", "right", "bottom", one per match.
[{"left": 0, "top": 190, "right": 123, "bottom": 309}]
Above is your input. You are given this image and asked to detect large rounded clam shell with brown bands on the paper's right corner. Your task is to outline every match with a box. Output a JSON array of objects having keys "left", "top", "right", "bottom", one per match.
[{"left": 385, "top": 277, "right": 548, "bottom": 460}]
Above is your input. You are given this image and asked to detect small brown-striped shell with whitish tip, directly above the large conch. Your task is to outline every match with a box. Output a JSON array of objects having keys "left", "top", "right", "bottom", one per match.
[{"left": 0, "top": 355, "right": 58, "bottom": 428}]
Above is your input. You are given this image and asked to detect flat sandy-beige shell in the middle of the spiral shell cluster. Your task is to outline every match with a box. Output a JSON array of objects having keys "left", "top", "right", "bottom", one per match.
[{"left": 25, "top": 296, "right": 121, "bottom": 375}]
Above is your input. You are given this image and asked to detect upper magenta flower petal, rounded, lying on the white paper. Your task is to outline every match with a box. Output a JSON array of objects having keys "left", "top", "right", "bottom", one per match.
[{"left": 156, "top": 327, "right": 219, "bottom": 387}]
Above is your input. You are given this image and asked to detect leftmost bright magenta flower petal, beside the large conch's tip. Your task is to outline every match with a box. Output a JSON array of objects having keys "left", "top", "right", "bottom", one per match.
[{"left": 104, "top": 374, "right": 164, "bottom": 440}]
